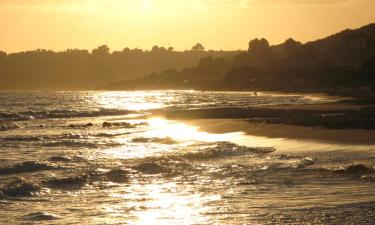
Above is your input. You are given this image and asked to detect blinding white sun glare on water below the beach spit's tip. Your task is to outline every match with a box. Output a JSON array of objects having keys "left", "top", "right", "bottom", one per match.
[{"left": 104, "top": 118, "right": 247, "bottom": 159}]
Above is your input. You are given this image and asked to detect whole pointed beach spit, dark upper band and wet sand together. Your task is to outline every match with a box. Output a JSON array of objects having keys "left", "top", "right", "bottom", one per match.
[{"left": 146, "top": 98, "right": 375, "bottom": 145}]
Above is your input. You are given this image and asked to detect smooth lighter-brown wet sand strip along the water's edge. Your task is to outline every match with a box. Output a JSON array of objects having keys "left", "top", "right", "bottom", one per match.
[{"left": 183, "top": 119, "right": 375, "bottom": 145}]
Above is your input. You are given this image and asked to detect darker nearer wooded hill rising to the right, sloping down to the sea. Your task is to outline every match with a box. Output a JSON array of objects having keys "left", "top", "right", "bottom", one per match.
[{"left": 105, "top": 24, "right": 375, "bottom": 91}]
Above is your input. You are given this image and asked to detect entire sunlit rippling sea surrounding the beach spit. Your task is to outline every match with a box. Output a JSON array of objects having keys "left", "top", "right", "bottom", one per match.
[{"left": 0, "top": 91, "right": 375, "bottom": 224}]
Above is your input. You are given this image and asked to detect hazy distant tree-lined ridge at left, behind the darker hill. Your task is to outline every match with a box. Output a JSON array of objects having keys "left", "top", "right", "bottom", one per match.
[{"left": 0, "top": 44, "right": 239, "bottom": 90}]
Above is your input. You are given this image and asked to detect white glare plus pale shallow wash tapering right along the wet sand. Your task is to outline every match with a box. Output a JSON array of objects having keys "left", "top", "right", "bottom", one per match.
[{"left": 104, "top": 118, "right": 373, "bottom": 162}]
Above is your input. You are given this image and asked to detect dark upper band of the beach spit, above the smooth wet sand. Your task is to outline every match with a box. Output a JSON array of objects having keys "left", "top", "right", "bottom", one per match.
[{"left": 149, "top": 92, "right": 375, "bottom": 130}]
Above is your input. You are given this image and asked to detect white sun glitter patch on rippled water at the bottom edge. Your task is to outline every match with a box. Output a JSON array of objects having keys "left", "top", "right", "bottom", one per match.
[{"left": 106, "top": 180, "right": 221, "bottom": 225}]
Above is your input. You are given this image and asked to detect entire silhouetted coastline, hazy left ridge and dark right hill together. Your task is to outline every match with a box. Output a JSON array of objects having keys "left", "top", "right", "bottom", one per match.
[{"left": 0, "top": 24, "right": 375, "bottom": 93}]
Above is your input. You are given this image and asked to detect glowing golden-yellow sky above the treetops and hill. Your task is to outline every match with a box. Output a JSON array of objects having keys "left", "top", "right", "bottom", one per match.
[{"left": 0, "top": 0, "right": 375, "bottom": 52}]
